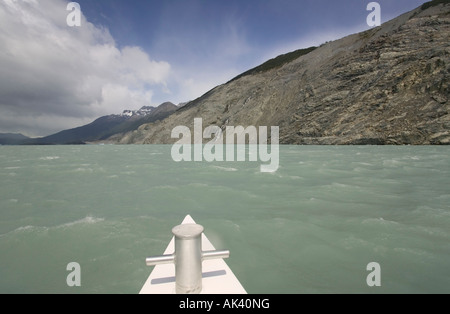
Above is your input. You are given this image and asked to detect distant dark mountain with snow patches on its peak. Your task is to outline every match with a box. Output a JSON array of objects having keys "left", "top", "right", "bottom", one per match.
[{"left": 22, "top": 102, "right": 178, "bottom": 145}]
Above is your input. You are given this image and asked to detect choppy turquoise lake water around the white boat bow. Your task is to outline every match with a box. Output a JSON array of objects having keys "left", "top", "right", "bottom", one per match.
[{"left": 0, "top": 145, "right": 450, "bottom": 294}]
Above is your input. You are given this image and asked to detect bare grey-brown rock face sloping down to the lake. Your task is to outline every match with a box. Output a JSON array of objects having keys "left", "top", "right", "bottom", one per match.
[{"left": 111, "top": 0, "right": 450, "bottom": 145}]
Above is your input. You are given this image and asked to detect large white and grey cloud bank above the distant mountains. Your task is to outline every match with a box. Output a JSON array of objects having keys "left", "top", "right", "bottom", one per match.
[{"left": 0, "top": 0, "right": 171, "bottom": 135}]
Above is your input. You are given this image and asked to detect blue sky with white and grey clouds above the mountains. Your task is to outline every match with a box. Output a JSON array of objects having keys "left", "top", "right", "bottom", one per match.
[{"left": 0, "top": 0, "right": 426, "bottom": 136}]
